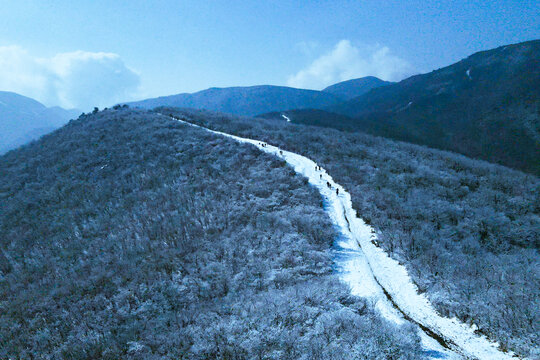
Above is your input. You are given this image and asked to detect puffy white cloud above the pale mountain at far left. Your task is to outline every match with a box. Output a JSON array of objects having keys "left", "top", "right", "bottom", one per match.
[{"left": 0, "top": 46, "right": 139, "bottom": 110}]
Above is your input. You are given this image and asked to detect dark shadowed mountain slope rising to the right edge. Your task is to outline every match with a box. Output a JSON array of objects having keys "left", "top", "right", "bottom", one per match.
[{"left": 327, "top": 40, "right": 540, "bottom": 174}]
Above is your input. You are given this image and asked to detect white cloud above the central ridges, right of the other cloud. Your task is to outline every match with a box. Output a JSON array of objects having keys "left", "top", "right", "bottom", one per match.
[{"left": 287, "top": 40, "right": 413, "bottom": 89}]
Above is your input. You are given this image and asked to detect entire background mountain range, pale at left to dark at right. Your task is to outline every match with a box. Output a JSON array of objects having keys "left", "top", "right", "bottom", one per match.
[{"left": 7, "top": 40, "right": 540, "bottom": 175}]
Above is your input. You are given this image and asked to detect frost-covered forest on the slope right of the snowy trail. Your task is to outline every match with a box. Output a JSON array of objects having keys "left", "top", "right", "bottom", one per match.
[{"left": 159, "top": 108, "right": 540, "bottom": 358}]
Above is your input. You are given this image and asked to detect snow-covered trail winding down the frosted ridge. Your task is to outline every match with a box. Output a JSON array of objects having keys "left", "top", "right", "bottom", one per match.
[{"left": 166, "top": 117, "right": 516, "bottom": 360}]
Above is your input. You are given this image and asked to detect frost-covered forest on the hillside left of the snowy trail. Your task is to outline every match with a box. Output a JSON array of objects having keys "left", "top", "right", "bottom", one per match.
[{"left": 0, "top": 108, "right": 422, "bottom": 359}]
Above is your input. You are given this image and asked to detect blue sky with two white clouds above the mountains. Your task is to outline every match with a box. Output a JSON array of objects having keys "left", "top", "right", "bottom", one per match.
[{"left": 0, "top": 0, "right": 540, "bottom": 108}]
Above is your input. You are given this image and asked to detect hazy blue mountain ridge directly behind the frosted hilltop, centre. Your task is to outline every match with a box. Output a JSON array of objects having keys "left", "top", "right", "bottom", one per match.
[{"left": 128, "top": 85, "right": 343, "bottom": 116}]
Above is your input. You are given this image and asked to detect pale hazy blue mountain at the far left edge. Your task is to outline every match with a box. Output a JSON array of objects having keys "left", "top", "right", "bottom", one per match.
[{"left": 0, "top": 91, "right": 80, "bottom": 154}]
